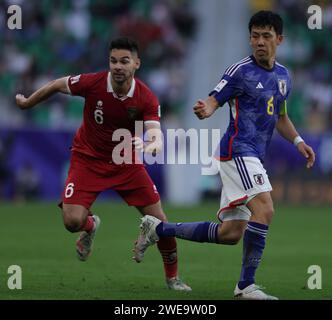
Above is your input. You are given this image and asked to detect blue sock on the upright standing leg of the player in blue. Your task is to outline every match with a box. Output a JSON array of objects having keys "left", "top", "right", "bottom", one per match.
[{"left": 238, "top": 221, "right": 269, "bottom": 290}]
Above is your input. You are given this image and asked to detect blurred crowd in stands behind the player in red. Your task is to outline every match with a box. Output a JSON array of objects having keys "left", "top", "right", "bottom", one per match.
[{"left": 0, "top": 0, "right": 196, "bottom": 128}]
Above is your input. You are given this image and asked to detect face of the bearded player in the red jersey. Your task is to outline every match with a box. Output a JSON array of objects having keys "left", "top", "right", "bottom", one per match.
[{"left": 110, "top": 49, "right": 140, "bottom": 85}]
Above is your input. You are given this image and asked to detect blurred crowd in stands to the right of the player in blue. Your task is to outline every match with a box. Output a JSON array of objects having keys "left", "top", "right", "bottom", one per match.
[{"left": 274, "top": 0, "right": 332, "bottom": 134}]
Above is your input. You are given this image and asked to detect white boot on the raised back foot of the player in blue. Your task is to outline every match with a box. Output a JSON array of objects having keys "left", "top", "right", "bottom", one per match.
[{"left": 133, "top": 215, "right": 161, "bottom": 262}]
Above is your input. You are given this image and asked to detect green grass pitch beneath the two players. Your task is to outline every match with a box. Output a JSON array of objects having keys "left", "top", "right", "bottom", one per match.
[{"left": 0, "top": 202, "right": 332, "bottom": 300}]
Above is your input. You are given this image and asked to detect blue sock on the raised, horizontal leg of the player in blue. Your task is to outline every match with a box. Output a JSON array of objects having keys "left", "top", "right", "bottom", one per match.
[{"left": 156, "top": 222, "right": 219, "bottom": 243}]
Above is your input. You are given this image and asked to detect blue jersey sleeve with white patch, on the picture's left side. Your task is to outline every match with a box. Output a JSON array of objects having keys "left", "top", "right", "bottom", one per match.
[{"left": 209, "top": 68, "right": 243, "bottom": 106}]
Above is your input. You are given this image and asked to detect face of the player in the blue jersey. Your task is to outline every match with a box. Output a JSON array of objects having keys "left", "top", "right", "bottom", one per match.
[{"left": 250, "top": 26, "right": 283, "bottom": 64}]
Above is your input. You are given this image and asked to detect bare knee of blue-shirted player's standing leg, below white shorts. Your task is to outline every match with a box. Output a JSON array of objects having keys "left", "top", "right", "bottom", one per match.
[{"left": 246, "top": 192, "right": 274, "bottom": 224}]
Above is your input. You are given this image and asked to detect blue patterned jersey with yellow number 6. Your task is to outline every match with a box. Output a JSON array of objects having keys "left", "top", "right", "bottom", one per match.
[{"left": 210, "top": 56, "right": 291, "bottom": 161}]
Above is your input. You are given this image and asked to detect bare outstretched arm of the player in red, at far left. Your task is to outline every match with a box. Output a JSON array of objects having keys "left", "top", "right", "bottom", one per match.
[{"left": 15, "top": 77, "right": 70, "bottom": 109}]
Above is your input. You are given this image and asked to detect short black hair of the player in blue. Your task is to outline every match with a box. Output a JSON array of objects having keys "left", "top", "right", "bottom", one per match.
[{"left": 249, "top": 10, "right": 283, "bottom": 35}]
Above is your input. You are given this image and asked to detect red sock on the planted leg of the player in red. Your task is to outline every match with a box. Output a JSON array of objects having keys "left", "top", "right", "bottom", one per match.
[{"left": 157, "top": 237, "right": 178, "bottom": 278}]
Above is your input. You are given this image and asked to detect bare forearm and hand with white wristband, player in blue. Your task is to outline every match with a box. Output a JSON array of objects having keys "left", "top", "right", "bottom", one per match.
[{"left": 276, "top": 112, "right": 315, "bottom": 169}]
